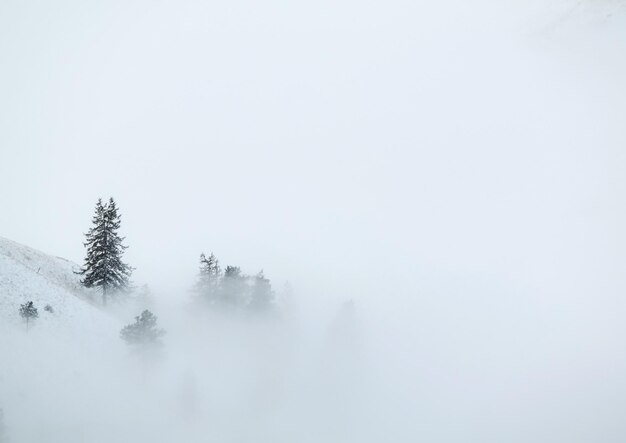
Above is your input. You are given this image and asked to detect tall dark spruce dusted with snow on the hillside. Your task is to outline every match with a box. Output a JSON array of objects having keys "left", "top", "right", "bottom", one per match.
[{"left": 79, "top": 198, "right": 133, "bottom": 305}]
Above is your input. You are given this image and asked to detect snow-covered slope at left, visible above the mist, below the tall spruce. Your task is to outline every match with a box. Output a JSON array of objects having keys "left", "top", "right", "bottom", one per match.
[{"left": 0, "top": 237, "right": 119, "bottom": 336}]
